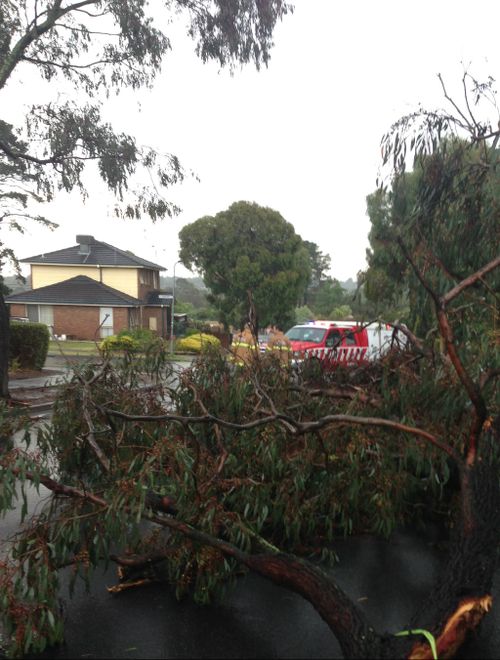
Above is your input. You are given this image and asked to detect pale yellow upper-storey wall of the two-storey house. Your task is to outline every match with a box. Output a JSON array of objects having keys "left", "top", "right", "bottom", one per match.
[{"left": 31, "top": 264, "right": 139, "bottom": 298}]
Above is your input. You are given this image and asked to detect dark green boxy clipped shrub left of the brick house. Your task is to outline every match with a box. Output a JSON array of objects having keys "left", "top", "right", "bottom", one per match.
[{"left": 9, "top": 321, "right": 50, "bottom": 369}]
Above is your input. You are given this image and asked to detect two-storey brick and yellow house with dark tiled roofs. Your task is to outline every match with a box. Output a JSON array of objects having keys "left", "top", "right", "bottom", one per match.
[{"left": 5, "top": 236, "right": 172, "bottom": 340}]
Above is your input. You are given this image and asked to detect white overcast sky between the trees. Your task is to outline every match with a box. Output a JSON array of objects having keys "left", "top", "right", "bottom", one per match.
[{"left": 0, "top": 0, "right": 500, "bottom": 279}]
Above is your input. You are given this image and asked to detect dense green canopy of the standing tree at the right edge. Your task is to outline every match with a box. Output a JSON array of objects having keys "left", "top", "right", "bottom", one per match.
[{"left": 364, "top": 136, "right": 500, "bottom": 332}]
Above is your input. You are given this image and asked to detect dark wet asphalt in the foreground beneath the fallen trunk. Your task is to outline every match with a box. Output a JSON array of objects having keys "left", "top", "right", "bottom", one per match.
[{"left": 26, "top": 533, "right": 500, "bottom": 658}]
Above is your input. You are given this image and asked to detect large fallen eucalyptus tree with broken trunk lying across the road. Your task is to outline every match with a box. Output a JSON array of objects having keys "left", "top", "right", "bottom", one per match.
[{"left": 0, "top": 75, "right": 500, "bottom": 658}]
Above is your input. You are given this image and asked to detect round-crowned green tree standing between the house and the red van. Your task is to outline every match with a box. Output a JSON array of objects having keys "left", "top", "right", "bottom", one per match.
[{"left": 179, "top": 202, "right": 310, "bottom": 328}]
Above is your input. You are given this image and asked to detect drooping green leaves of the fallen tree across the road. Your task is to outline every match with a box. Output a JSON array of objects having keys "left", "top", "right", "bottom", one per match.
[{"left": 0, "top": 350, "right": 464, "bottom": 654}]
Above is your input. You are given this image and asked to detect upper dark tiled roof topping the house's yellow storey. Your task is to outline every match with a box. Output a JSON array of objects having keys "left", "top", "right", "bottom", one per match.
[{"left": 21, "top": 238, "right": 166, "bottom": 270}]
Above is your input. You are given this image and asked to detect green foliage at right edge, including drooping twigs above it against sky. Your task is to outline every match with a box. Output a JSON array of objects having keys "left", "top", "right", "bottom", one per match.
[{"left": 365, "top": 74, "right": 500, "bottom": 340}]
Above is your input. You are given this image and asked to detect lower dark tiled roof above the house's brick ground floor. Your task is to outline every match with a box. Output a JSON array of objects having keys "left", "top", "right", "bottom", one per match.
[{"left": 5, "top": 275, "right": 144, "bottom": 307}]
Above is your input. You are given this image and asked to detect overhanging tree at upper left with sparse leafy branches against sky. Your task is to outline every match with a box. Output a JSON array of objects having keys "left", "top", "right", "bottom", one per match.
[{"left": 0, "top": 0, "right": 291, "bottom": 397}]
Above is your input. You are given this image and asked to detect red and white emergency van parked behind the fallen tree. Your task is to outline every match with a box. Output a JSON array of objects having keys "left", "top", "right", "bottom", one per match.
[{"left": 285, "top": 321, "right": 406, "bottom": 364}]
